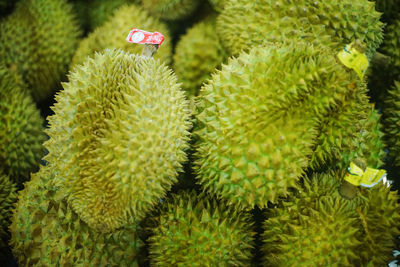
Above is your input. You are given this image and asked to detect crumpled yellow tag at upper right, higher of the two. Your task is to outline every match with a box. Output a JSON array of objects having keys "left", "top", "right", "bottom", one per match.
[{"left": 337, "top": 43, "right": 369, "bottom": 79}]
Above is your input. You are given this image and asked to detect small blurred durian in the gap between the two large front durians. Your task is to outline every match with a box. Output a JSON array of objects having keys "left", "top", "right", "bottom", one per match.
[{"left": 174, "top": 19, "right": 227, "bottom": 96}]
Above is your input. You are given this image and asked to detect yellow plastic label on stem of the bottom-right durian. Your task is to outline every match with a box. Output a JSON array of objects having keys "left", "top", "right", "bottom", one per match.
[{"left": 344, "top": 162, "right": 386, "bottom": 187}]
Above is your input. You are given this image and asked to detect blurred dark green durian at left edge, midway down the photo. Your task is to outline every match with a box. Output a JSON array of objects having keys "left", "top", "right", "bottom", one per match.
[{"left": 0, "top": 64, "right": 46, "bottom": 183}]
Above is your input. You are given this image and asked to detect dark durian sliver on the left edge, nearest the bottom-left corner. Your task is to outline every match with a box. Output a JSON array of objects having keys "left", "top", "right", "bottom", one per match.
[{"left": 0, "top": 169, "right": 17, "bottom": 264}]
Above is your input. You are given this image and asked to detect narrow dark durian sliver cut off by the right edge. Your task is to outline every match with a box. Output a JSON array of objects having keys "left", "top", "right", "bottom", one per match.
[{"left": 382, "top": 81, "right": 400, "bottom": 166}]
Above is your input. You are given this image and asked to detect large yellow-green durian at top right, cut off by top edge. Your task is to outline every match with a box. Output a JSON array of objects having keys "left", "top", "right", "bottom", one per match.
[{"left": 217, "top": 0, "right": 383, "bottom": 56}]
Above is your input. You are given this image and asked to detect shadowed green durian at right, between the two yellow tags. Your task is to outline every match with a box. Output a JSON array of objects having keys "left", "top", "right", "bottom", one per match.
[{"left": 310, "top": 87, "right": 385, "bottom": 170}]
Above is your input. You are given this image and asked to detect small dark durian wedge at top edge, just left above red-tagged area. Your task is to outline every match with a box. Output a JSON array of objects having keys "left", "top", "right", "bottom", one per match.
[{"left": 87, "top": 0, "right": 139, "bottom": 30}]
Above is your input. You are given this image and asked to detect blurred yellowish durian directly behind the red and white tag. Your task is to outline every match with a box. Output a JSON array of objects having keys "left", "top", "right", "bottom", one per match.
[{"left": 70, "top": 4, "right": 172, "bottom": 69}]
